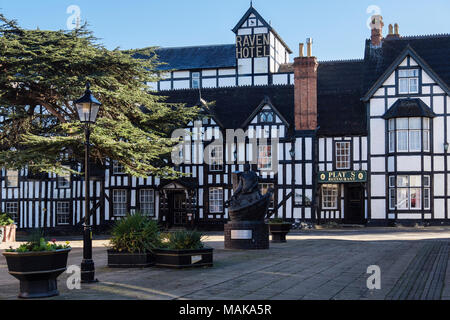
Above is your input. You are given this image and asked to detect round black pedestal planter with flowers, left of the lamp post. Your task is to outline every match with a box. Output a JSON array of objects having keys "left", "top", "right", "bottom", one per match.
[{"left": 3, "top": 232, "right": 71, "bottom": 299}]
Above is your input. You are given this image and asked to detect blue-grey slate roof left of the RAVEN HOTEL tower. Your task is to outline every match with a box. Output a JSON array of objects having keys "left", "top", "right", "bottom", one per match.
[{"left": 149, "top": 44, "right": 236, "bottom": 71}]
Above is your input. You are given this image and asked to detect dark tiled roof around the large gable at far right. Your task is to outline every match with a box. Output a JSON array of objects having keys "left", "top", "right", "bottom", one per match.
[{"left": 363, "top": 35, "right": 450, "bottom": 99}]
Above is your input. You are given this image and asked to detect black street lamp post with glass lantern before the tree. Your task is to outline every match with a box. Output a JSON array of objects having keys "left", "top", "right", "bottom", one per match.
[{"left": 74, "top": 82, "right": 102, "bottom": 283}]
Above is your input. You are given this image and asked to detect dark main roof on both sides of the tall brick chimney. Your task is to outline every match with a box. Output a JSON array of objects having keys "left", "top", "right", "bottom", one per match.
[{"left": 158, "top": 61, "right": 367, "bottom": 136}]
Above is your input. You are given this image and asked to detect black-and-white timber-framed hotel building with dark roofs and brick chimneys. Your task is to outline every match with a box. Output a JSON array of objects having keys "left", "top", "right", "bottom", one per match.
[{"left": 0, "top": 7, "right": 450, "bottom": 230}]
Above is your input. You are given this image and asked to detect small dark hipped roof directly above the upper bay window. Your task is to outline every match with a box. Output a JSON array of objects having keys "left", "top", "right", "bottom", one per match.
[{"left": 383, "top": 98, "right": 436, "bottom": 120}]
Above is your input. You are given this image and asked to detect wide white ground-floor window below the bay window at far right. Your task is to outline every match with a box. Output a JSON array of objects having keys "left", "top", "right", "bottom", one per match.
[{"left": 389, "top": 175, "right": 431, "bottom": 210}]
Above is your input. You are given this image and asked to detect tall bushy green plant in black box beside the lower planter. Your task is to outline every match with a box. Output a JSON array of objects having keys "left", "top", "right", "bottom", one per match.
[{"left": 108, "top": 212, "right": 160, "bottom": 268}]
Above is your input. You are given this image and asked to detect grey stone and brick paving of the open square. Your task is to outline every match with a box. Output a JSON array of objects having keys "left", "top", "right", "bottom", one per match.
[{"left": 0, "top": 227, "right": 450, "bottom": 300}]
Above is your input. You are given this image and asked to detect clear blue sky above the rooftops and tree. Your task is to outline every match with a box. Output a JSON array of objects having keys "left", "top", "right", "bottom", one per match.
[{"left": 0, "top": 0, "right": 450, "bottom": 60}]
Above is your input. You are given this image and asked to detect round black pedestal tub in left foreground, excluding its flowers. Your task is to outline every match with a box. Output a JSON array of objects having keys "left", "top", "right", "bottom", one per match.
[{"left": 3, "top": 249, "right": 70, "bottom": 299}]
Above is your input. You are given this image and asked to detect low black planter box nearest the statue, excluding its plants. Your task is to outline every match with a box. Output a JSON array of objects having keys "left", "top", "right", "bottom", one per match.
[{"left": 154, "top": 248, "right": 214, "bottom": 269}]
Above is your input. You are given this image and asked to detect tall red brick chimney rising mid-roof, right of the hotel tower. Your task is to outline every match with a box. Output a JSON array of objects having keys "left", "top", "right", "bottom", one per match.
[{"left": 294, "top": 39, "right": 319, "bottom": 130}]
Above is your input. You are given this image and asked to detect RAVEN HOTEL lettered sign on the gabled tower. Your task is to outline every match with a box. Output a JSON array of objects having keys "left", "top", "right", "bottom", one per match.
[{"left": 236, "top": 33, "right": 270, "bottom": 59}]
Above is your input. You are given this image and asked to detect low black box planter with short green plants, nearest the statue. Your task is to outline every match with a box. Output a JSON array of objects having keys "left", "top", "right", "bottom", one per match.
[{"left": 154, "top": 231, "right": 213, "bottom": 269}]
